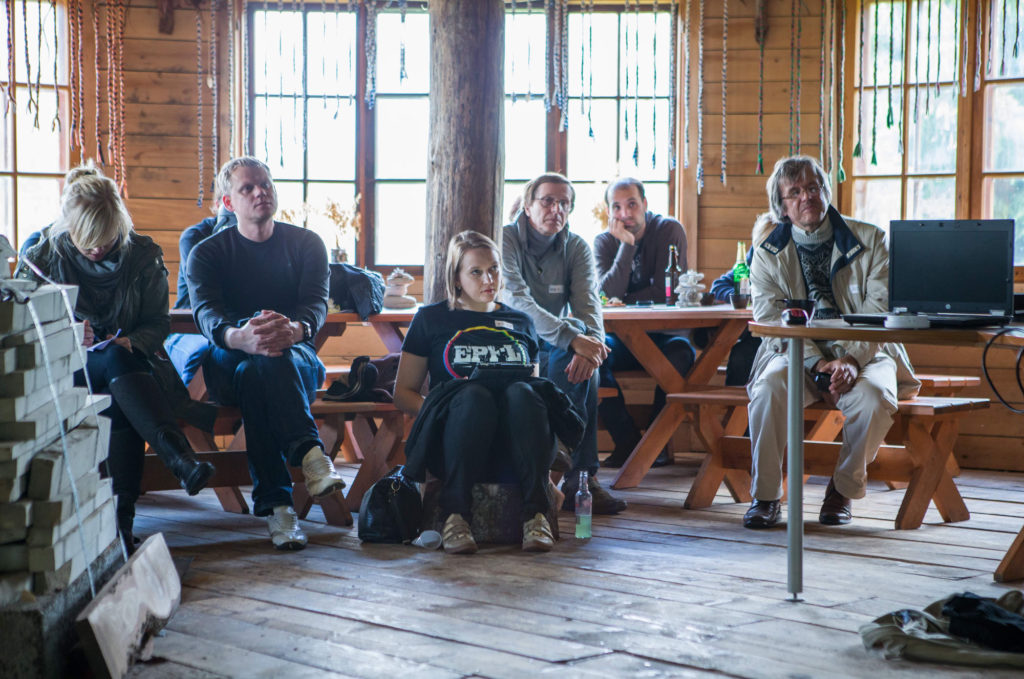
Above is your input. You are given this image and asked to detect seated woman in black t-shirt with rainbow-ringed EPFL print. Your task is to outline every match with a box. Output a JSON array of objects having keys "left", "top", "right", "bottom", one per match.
[{"left": 394, "top": 231, "right": 555, "bottom": 554}]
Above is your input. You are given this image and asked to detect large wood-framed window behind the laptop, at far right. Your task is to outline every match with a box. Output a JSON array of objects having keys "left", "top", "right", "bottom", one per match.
[{"left": 843, "top": 0, "right": 1024, "bottom": 262}]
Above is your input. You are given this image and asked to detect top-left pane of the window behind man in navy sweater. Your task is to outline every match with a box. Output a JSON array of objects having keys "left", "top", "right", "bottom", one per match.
[{"left": 253, "top": 10, "right": 304, "bottom": 94}]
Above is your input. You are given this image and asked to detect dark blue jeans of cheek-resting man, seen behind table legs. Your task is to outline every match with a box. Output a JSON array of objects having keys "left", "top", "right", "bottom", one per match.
[{"left": 600, "top": 333, "right": 696, "bottom": 456}]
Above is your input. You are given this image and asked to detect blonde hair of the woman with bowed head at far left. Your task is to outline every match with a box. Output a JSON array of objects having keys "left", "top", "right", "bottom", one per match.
[{"left": 51, "top": 174, "right": 133, "bottom": 250}]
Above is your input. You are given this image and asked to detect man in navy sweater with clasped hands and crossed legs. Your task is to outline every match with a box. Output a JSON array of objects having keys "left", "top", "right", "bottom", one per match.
[{"left": 185, "top": 157, "right": 345, "bottom": 549}]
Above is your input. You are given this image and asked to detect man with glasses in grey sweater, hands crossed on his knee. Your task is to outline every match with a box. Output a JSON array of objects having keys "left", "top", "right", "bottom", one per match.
[{"left": 502, "top": 173, "right": 626, "bottom": 514}]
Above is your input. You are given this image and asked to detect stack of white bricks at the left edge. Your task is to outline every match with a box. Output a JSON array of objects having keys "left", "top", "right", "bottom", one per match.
[{"left": 0, "top": 286, "right": 117, "bottom": 606}]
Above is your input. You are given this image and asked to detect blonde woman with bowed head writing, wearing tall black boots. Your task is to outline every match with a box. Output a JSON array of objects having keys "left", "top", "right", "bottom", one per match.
[{"left": 20, "top": 174, "right": 214, "bottom": 553}]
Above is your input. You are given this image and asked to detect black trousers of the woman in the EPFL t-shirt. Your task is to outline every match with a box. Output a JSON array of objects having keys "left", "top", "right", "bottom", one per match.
[{"left": 438, "top": 382, "right": 555, "bottom": 520}]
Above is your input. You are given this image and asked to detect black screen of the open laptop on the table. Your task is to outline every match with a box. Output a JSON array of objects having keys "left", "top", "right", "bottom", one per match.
[{"left": 889, "top": 219, "right": 1014, "bottom": 315}]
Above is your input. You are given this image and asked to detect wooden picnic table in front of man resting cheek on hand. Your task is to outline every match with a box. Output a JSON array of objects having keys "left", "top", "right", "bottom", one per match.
[{"left": 604, "top": 304, "right": 752, "bottom": 491}]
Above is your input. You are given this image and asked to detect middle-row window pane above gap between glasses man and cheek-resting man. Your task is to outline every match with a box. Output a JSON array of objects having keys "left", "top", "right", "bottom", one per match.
[{"left": 567, "top": 99, "right": 618, "bottom": 181}]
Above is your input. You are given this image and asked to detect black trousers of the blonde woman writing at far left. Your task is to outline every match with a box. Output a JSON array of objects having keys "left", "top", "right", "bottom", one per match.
[{"left": 75, "top": 344, "right": 150, "bottom": 500}]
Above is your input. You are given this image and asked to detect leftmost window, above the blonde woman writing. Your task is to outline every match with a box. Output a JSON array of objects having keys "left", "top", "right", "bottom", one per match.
[{"left": 0, "top": 0, "right": 70, "bottom": 247}]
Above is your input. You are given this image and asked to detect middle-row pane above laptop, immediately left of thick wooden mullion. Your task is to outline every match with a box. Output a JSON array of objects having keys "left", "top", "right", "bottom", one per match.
[{"left": 906, "top": 86, "right": 956, "bottom": 174}]
